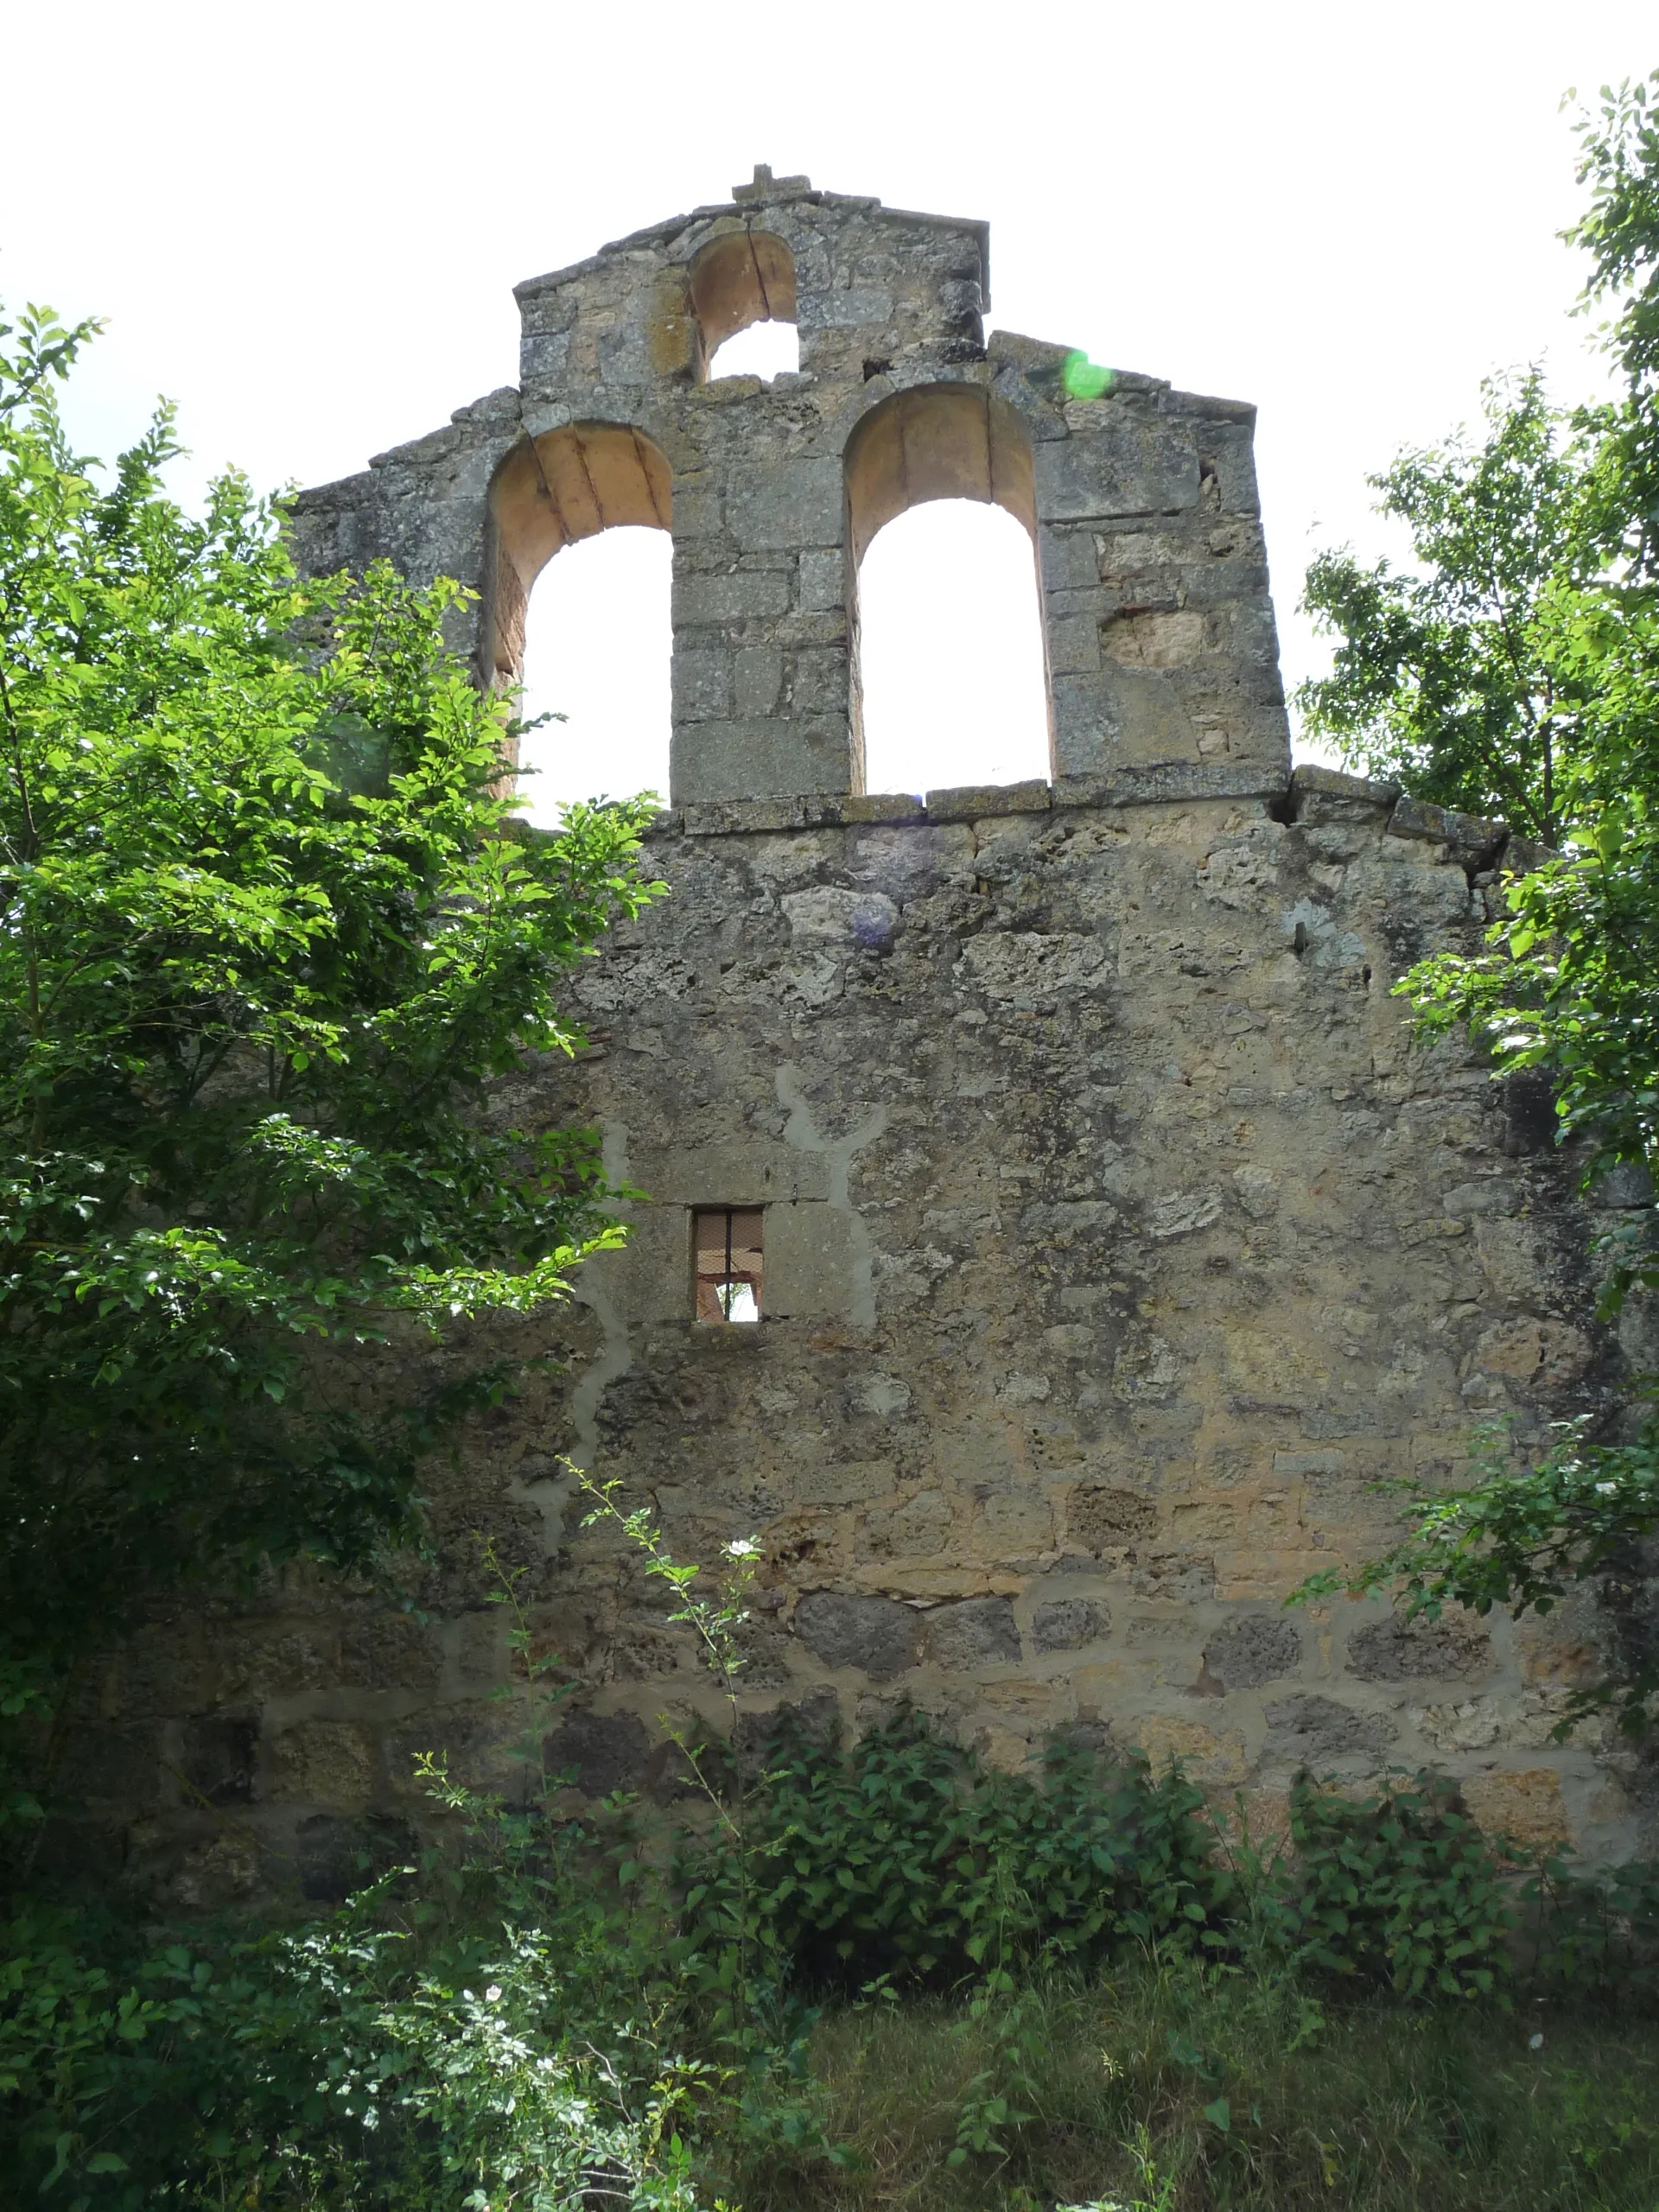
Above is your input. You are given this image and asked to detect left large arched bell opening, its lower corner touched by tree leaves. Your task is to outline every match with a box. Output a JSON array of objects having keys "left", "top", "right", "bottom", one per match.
[{"left": 485, "top": 423, "right": 672, "bottom": 823}]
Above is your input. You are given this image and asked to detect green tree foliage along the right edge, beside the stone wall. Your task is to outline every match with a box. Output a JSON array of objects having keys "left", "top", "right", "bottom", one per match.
[{"left": 1299, "top": 73, "right": 1659, "bottom": 1732}]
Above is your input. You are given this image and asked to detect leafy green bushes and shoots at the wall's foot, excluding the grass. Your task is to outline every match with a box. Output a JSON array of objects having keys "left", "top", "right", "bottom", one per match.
[{"left": 0, "top": 1451, "right": 1659, "bottom": 2212}]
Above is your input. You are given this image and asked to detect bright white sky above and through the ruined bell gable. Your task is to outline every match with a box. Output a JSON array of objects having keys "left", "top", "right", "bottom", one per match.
[{"left": 0, "top": 0, "right": 1659, "bottom": 814}]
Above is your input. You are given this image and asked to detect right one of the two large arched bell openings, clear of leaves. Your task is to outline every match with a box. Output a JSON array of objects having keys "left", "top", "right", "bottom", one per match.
[{"left": 845, "top": 385, "right": 1053, "bottom": 791}]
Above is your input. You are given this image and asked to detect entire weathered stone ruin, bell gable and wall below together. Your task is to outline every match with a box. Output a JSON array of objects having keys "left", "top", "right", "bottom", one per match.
[{"left": 68, "top": 175, "right": 1648, "bottom": 1897}]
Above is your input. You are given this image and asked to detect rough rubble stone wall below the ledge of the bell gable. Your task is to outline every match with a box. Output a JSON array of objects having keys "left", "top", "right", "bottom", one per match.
[{"left": 81, "top": 772, "right": 1643, "bottom": 1896}]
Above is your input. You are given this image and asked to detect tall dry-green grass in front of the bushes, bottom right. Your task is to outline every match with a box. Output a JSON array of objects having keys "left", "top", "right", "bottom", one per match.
[{"left": 708, "top": 1958, "right": 1659, "bottom": 2212}]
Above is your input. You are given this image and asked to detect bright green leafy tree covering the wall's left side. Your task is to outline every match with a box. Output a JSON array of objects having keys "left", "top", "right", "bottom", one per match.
[{"left": 0, "top": 309, "right": 657, "bottom": 1760}]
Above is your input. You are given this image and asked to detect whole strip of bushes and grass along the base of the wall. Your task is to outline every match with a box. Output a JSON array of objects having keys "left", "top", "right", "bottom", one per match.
[{"left": 0, "top": 1714, "right": 1659, "bottom": 2212}]
